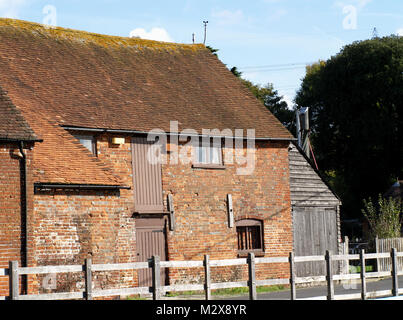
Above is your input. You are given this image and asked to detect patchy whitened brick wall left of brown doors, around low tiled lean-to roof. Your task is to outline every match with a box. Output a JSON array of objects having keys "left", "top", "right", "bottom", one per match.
[{"left": 29, "top": 136, "right": 137, "bottom": 292}]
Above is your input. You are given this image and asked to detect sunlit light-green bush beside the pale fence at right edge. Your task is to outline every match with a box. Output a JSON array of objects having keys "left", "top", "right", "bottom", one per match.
[{"left": 362, "top": 195, "right": 402, "bottom": 239}]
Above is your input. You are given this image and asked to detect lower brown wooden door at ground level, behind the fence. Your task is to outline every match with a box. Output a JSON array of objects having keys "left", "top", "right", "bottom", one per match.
[{"left": 136, "top": 218, "right": 167, "bottom": 287}]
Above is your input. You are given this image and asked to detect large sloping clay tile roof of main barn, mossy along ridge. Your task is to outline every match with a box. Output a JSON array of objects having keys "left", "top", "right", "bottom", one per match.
[{"left": 0, "top": 19, "right": 293, "bottom": 140}]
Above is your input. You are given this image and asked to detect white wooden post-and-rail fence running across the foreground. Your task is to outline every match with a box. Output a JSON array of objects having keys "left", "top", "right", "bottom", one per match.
[{"left": 0, "top": 248, "right": 403, "bottom": 300}]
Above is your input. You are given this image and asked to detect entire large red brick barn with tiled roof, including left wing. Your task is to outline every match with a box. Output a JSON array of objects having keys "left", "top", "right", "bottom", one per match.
[{"left": 0, "top": 19, "right": 300, "bottom": 295}]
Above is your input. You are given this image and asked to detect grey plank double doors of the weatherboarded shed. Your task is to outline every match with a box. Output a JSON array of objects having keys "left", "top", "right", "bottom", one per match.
[{"left": 293, "top": 207, "right": 338, "bottom": 277}]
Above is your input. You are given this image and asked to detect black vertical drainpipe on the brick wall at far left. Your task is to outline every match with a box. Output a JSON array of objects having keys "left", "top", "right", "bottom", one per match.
[{"left": 19, "top": 141, "right": 28, "bottom": 294}]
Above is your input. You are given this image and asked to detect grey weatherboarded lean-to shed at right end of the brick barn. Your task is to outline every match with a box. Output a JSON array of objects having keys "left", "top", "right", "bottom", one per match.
[{"left": 289, "top": 143, "right": 341, "bottom": 277}]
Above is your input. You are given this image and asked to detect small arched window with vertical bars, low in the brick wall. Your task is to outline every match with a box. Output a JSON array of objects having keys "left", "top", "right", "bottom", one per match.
[{"left": 236, "top": 219, "right": 264, "bottom": 254}]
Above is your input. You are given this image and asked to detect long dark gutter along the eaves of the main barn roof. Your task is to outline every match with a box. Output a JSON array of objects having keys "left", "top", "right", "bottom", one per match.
[{"left": 61, "top": 125, "right": 298, "bottom": 141}]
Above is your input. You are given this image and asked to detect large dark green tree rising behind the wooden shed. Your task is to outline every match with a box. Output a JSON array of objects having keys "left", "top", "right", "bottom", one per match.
[{"left": 296, "top": 36, "right": 403, "bottom": 216}]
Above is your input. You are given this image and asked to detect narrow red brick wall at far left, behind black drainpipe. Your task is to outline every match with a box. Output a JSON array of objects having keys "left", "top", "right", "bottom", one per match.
[{"left": 0, "top": 143, "right": 33, "bottom": 296}]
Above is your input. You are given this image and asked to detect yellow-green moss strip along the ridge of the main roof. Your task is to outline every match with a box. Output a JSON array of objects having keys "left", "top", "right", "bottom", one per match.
[{"left": 0, "top": 18, "right": 207, "bottom": 51}]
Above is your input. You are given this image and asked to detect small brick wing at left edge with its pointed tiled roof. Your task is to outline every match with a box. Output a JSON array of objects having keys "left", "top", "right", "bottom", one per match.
[{"left": 0, "top": 87, "right": 41, "bottom": 295}]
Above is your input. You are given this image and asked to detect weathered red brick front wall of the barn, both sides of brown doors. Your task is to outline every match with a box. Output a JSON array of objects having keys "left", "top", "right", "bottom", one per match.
[{"left": 7, "top": 135, "right": 292, "bottom": 291}]
